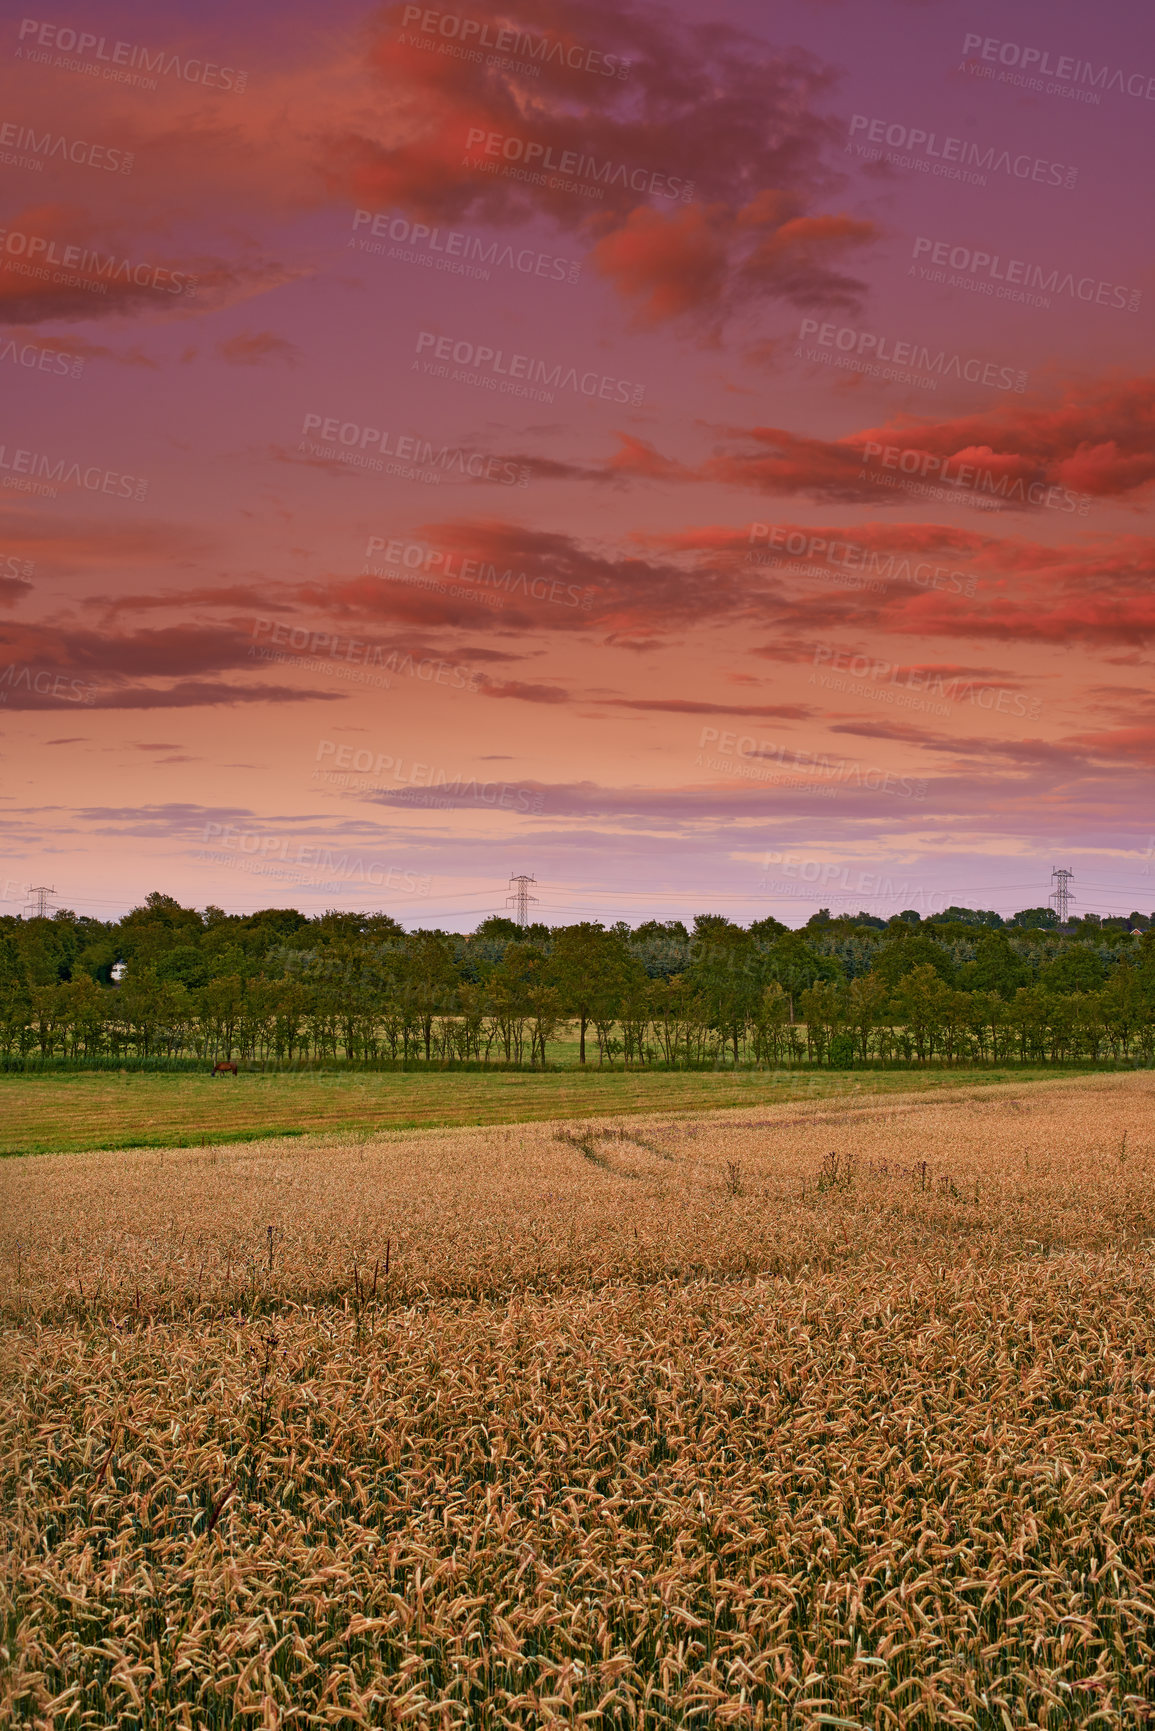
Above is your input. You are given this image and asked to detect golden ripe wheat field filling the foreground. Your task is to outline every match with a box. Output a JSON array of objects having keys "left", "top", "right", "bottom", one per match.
[{"left": 0, "top": 1073, "right": 1155, "bottom": 1731}]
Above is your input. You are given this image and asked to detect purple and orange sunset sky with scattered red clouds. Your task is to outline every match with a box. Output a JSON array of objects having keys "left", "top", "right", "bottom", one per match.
[{"left": 0, "top": 0, "right": 1155, "bottom": 930}]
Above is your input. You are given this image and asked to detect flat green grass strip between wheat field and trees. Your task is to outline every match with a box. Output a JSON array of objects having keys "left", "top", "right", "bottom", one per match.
[{"left": 0, "top": 1068, "right": 1108, "bottom": 1155}]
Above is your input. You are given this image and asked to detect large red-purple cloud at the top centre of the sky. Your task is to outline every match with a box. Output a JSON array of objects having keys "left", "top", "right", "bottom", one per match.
[{"left": 324, "top": 0, "right": 876, "bottom": 327}]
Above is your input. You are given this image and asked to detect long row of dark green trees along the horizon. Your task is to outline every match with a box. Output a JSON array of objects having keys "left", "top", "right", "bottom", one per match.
[{"left": 0, "top": 891, "right": 1155, "bottom": 1068}]
